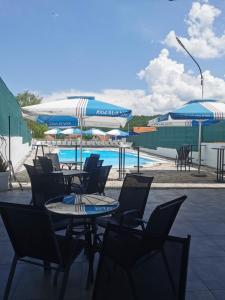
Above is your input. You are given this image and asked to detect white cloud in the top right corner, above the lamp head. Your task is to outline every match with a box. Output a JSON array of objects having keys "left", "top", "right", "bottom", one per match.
[{"left": 164, "top": 2, "right": 225, "bottom": 59}]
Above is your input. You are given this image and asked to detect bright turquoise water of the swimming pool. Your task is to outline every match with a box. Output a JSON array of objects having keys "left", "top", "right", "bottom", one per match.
[{"left": 58, "top": 149, "right": 160, "bottom": 168}]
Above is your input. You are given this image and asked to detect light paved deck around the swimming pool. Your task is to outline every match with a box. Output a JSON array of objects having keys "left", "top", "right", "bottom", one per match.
[{"left": 17, "top": 148, "right": 225, "bottom": 189}]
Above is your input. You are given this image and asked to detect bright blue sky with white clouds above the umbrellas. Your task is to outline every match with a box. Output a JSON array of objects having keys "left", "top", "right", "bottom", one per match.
[{"left": 0, "top": 0, "right": 225, "bottom": 115}]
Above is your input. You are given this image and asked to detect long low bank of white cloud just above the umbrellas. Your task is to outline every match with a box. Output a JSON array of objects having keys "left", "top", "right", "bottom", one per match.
[{"left": 41, "top": 49, "right": 225, "bottom": 115}]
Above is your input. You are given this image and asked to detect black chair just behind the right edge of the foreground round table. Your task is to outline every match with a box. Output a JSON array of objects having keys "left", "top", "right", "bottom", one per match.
[{"left": 97, "top": 174, "right": 154, "bottom": 228}]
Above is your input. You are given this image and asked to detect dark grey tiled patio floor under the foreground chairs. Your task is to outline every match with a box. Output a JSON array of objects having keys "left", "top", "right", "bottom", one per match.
[{"left": 0, "top": 189, "right": 225, "bottom": 300}]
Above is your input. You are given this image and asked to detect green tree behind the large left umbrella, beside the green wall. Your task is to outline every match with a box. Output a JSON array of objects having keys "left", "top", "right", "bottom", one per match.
[{"left": 16, "top": 91, "right": 48, "bottom": 138}]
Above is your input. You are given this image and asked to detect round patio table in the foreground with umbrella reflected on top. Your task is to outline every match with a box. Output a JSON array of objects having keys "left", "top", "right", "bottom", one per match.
[{"left": 45, "top": 194, "right": 119, "bottom": 287}]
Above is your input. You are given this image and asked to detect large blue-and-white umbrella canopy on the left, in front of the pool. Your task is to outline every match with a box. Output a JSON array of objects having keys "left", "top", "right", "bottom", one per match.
[{"left": 22, "top": 96, "right": 131, "bottom": 128}]
